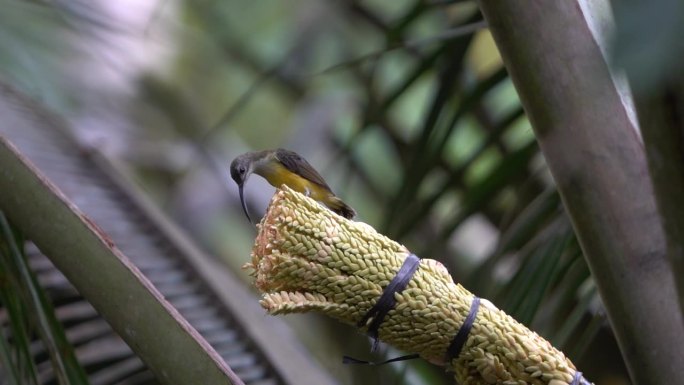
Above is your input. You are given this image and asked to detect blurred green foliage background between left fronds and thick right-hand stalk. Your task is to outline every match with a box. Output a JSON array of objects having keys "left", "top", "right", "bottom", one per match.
[{"left": 0, "top": 0, "right": 668, "bottom": 384}]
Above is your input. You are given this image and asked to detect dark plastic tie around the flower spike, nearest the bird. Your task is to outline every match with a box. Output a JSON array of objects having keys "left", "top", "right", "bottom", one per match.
[{"left": 356, "top": 253, "right": 420, "bottom": 352}]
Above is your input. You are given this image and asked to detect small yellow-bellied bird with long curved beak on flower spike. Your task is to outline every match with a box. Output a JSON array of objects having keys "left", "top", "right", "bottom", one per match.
[{"left": 230, "top": 148, "right": 356, "bottom": 222}]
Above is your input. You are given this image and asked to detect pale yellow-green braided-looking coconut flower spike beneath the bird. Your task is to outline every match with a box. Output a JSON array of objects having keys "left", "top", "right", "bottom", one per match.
[{"left": 245, "top": 186, "right": 589, "bottom": 385}]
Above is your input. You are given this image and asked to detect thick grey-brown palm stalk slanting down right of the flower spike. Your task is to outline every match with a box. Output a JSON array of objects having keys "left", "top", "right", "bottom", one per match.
[{"left": 480, "top": 0, "right": 684, "bottom": 384}]
